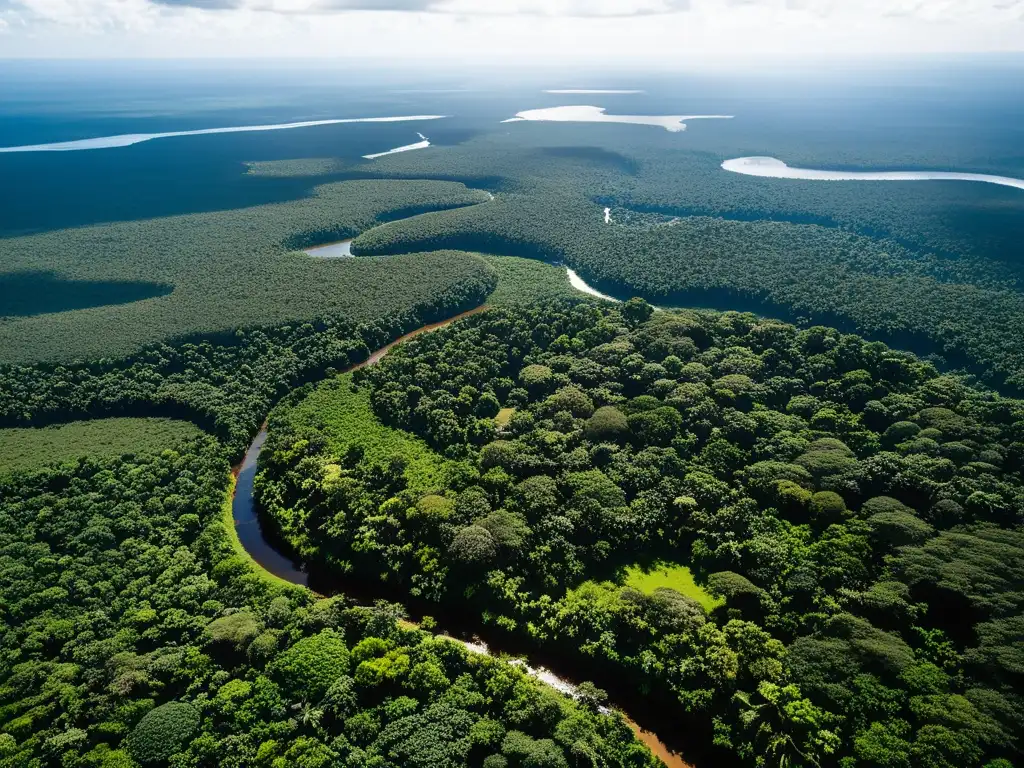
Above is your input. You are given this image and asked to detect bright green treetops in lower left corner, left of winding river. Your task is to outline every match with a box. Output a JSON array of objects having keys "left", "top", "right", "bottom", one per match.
[{"left": 0, "top": 437, "right": 657, "bottom": 768}]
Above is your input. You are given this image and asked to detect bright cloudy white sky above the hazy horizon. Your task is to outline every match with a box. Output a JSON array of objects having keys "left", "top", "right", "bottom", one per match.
[{"left": 0, "top": 0, "right": 1024, "bottom": 60}]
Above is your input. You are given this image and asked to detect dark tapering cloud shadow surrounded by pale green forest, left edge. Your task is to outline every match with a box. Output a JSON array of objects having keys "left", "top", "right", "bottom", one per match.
[{"left": 0, "top": 270, "right": 174, "bottom": 317}]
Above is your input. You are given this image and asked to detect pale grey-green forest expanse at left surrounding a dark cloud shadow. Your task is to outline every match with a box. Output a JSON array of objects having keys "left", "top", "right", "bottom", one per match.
[{"left": 0, "top": 180, "right": 487, "bottom": 364}]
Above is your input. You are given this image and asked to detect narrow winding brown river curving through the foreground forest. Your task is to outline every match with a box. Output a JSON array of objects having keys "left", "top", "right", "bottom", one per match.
[{"left": 231, "top": 304, "right": 693, "bottom": 768}]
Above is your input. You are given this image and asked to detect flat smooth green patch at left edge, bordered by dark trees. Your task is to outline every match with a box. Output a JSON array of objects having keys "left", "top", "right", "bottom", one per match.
[{"left": 0, "top": 419, "right": 201, "bottom": 474}]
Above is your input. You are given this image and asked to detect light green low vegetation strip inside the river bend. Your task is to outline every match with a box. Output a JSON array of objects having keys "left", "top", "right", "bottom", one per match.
[{"left": 280, "top": 374, "right": 447, "bottom": 492}]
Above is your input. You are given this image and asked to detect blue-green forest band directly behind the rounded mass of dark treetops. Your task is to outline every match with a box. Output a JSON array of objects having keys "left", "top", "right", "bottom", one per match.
[{"left": 352, "top": 196, "right": 1024, "bottom": 390}]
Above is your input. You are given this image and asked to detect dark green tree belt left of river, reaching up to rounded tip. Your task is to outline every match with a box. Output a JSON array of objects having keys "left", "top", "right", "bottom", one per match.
[{"left": 0, "top": 260, "right": 497, "bottom": 456}]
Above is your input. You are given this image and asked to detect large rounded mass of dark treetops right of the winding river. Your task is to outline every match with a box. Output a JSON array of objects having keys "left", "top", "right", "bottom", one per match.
[{"left": 257, "top": 300, "right": 1024, "bottom": 768}]
